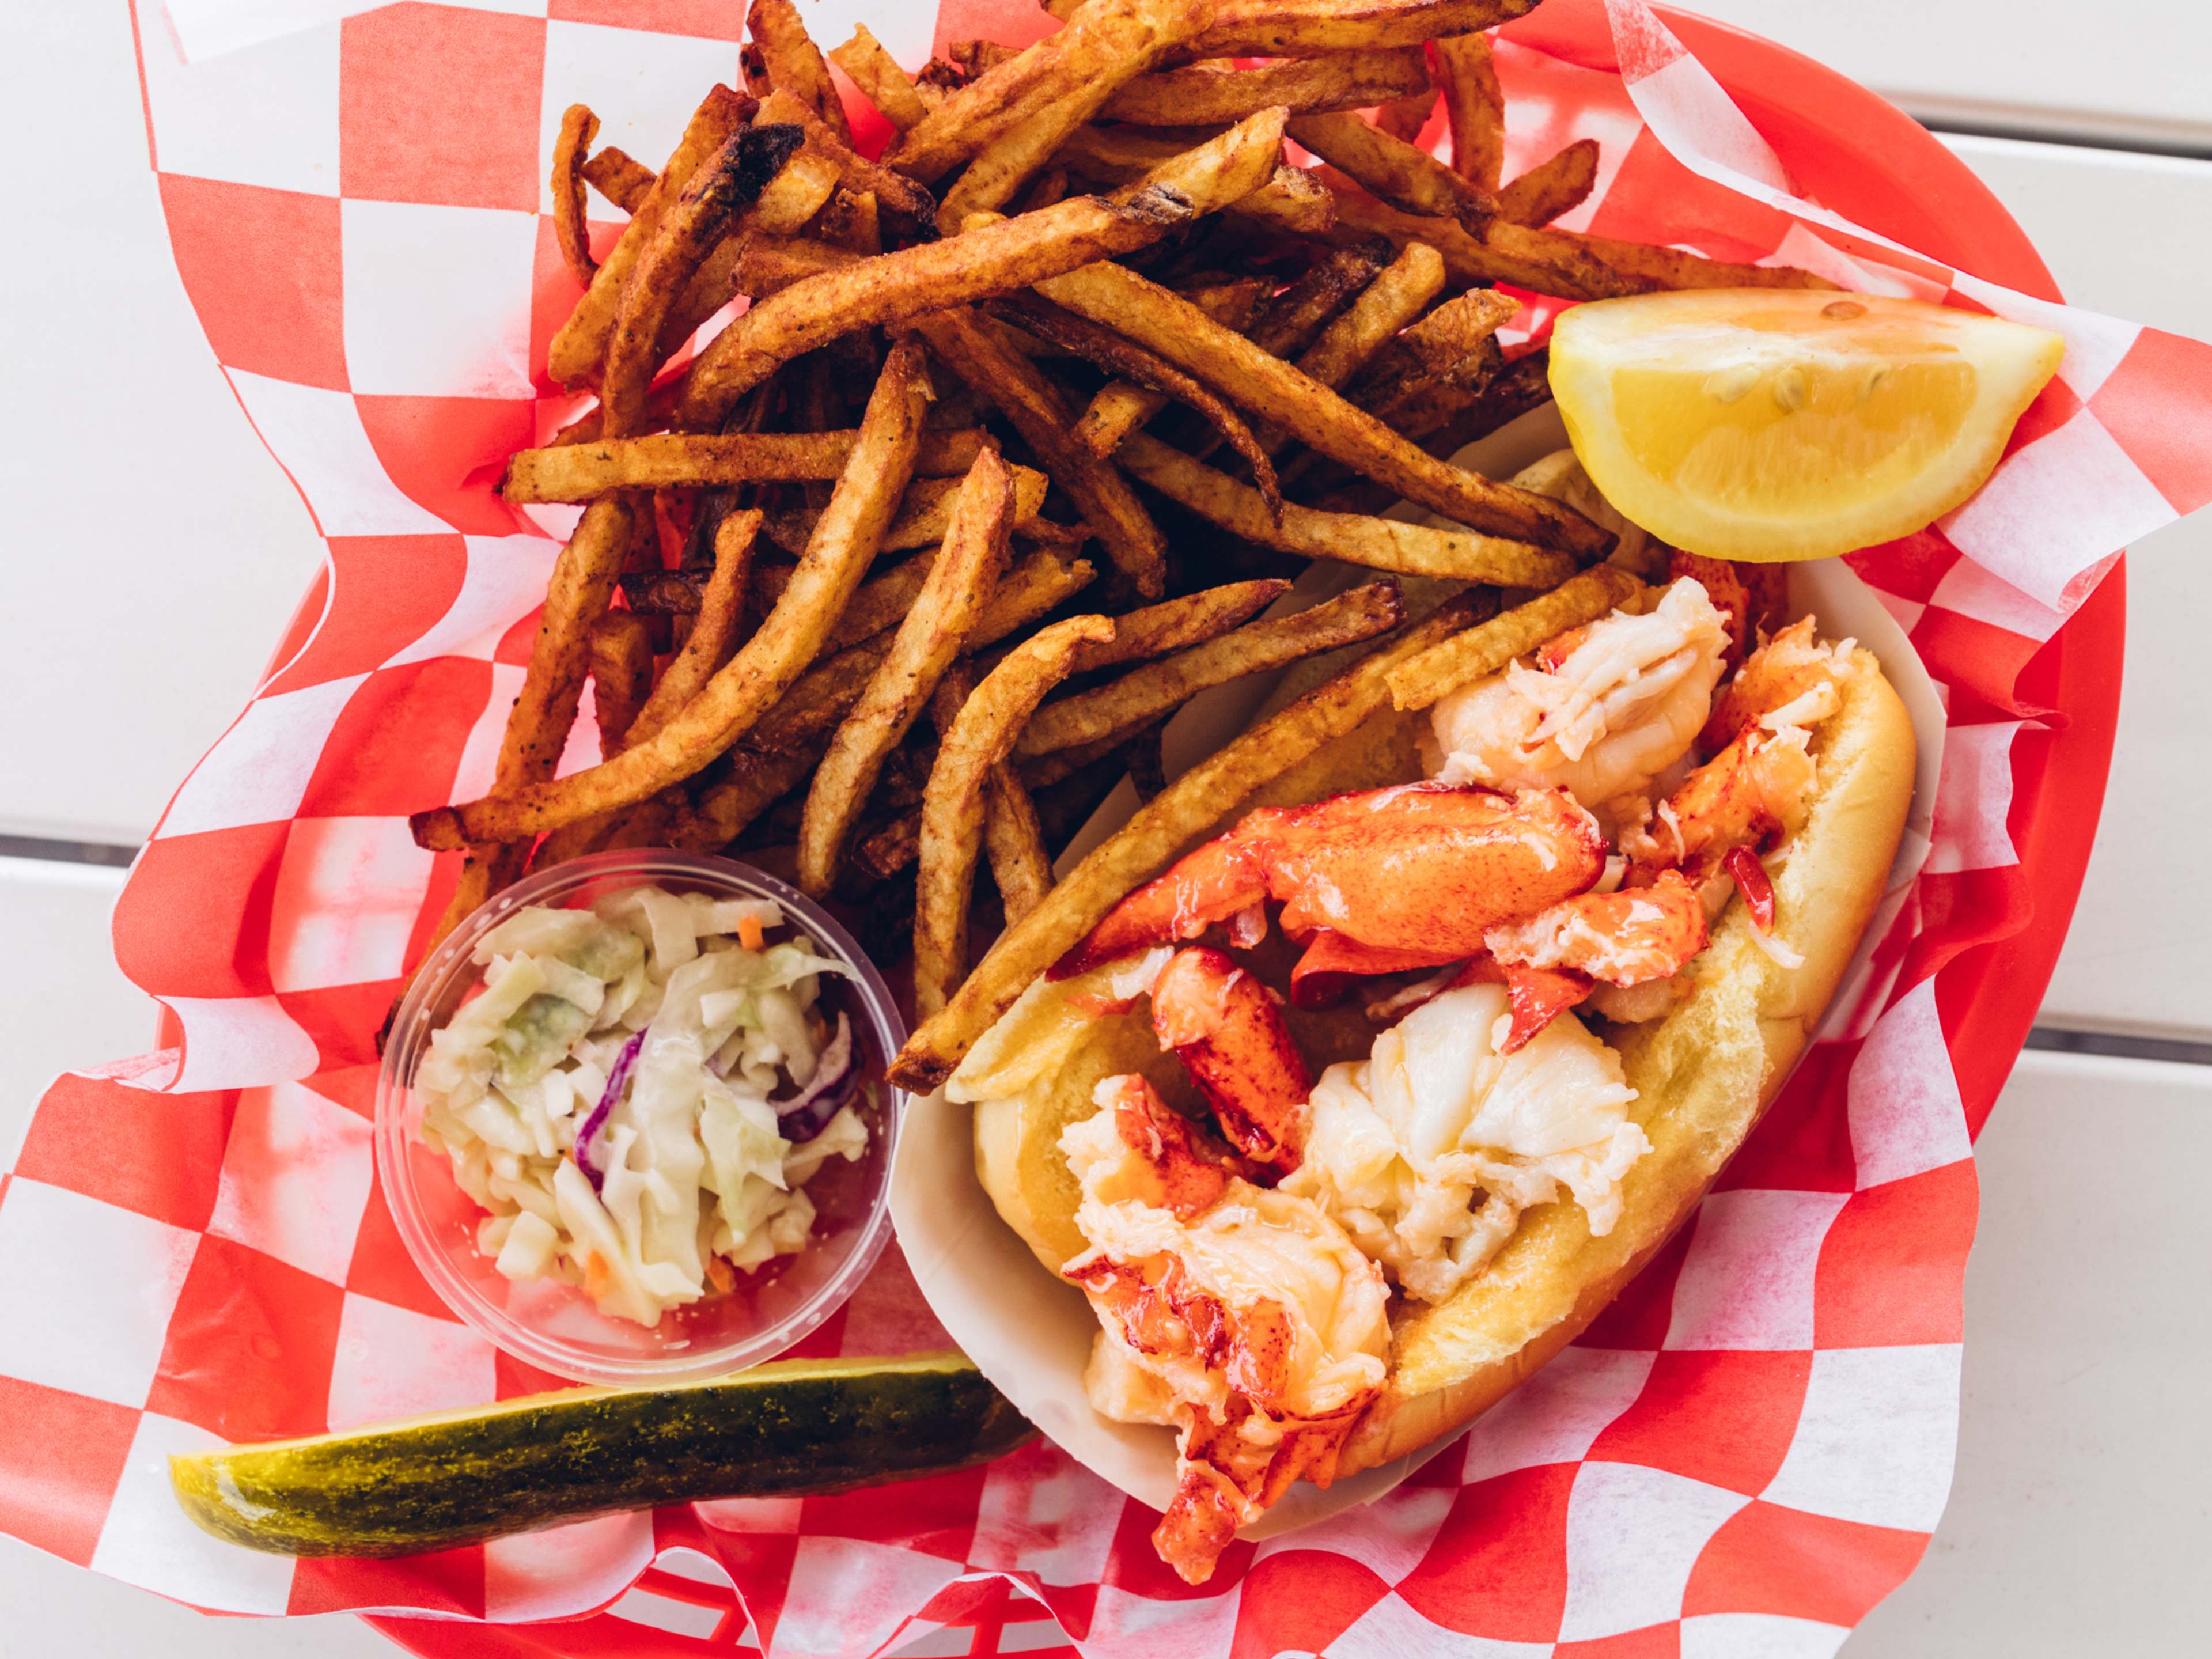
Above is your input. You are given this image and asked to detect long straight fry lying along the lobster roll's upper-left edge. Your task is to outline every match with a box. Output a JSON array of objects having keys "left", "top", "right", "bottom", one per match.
[{"left": 889, "top": 593, "right": 1480, "bottom": 1093}]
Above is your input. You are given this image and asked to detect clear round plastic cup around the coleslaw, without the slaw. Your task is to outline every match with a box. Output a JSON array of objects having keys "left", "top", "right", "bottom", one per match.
[{"left": 376, "top": 850, "right": 907, "bottom": 1385}]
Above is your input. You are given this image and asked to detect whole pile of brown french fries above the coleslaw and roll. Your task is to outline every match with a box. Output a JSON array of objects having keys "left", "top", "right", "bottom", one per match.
[{"left": 414, "top": 0, "right": 1823, "bottom": 1057}]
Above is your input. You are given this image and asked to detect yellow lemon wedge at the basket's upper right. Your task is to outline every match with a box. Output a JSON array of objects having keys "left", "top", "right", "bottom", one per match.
[{"left": 1551, "top": 287, "right": 2066, "bottom": 560}]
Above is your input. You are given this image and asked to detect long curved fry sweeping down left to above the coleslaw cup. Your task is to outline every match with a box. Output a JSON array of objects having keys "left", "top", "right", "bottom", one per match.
[{"left": 411, "top": 340, "right": 929, "bottom": 847}]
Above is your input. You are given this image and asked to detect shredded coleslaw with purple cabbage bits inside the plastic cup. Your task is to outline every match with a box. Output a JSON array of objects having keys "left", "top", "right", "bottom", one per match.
[{"left": 416, "top": 887, "right": 867, "bottom": 1325}]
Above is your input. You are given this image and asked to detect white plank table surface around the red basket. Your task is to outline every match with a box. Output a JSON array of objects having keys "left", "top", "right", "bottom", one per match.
[{"left": 0, "top": 0, "right": 2212, "bottom": 1659}]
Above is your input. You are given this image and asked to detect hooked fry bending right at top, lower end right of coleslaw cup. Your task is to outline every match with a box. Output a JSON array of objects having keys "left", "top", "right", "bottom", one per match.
[{"left": 914, "top": 617, "right": 1113, "bottom": 1020}]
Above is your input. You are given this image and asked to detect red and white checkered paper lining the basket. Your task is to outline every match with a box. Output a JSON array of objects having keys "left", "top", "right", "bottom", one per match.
[{"left": 17, "top": 0, "right": 2212, "bottom": 1659}]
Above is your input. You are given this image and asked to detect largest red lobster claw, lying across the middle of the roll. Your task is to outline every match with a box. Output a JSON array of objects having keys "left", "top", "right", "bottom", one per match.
[{"left": 1051, "top": 783, "right": 1606, "bottom": 980}]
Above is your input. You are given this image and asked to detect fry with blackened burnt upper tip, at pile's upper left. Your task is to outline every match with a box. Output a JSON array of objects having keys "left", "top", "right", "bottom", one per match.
[{"left": 600, "top": 124, "right": 801, "bottom": 438}]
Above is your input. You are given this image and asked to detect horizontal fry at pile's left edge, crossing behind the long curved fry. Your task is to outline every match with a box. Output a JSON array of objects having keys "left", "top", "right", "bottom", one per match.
[{"left": 500, "top": 427, "right": 984, "bottom": 502}]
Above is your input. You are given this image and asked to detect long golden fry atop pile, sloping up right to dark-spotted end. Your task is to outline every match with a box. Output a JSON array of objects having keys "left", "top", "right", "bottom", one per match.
[{"left": 675, "top": 115, "right": 1281, "bottom": 431}]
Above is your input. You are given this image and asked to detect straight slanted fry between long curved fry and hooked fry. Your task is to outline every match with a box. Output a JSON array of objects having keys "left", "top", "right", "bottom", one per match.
[{"left": 798, "top": 451, "right": 1013, "bottom": 898}]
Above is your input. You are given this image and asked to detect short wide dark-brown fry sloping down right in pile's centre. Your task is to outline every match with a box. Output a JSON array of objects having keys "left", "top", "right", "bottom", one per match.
[{"left": 916, "top": 310, "right": 1168, "bottom": 597}]
